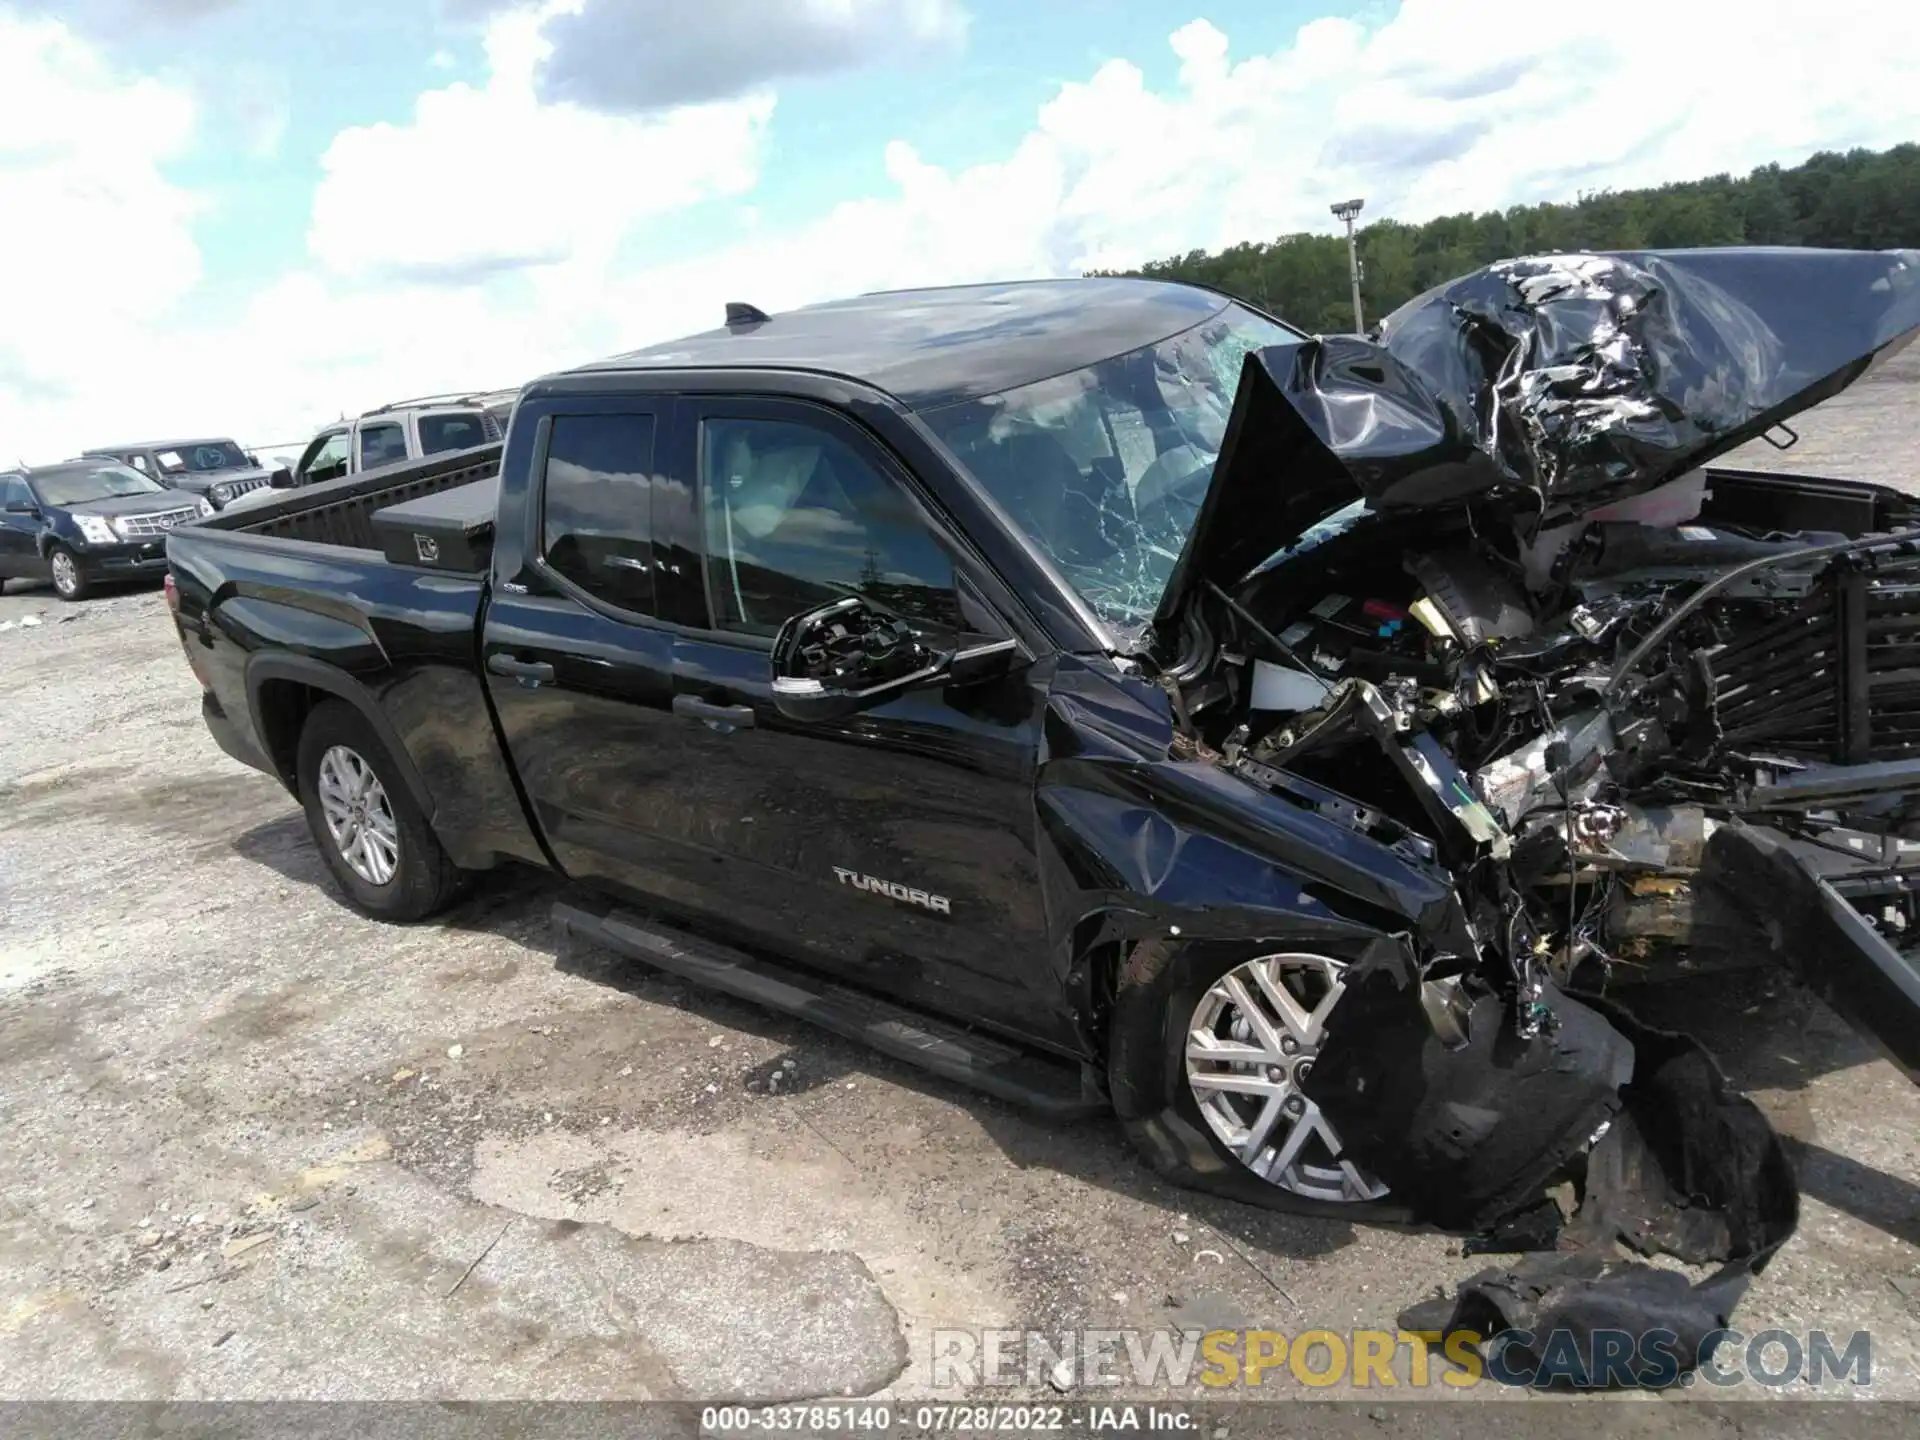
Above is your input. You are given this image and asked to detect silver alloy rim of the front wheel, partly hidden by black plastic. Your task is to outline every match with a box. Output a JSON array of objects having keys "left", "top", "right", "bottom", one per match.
[{"left": 1187, "top": 954, "right": 1386, "bottom": 1204}]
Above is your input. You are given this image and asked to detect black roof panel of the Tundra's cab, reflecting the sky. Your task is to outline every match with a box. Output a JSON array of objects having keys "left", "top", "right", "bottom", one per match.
[{"left": 568, "top": 276, "right": 1231, "bottom": 409}]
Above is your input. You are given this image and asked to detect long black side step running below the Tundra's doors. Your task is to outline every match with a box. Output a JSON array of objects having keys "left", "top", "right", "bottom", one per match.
[{"left": 553, "top": 902, "right": 1108, "bottom": 1119}]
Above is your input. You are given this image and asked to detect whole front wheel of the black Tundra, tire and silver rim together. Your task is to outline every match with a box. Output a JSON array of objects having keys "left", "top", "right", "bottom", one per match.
[{"left": 1108, "top": 941, "right": 1415, "bottom": 1225}]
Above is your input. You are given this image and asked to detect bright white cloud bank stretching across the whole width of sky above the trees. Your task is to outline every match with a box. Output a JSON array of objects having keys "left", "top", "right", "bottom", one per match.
[{"left": 0, "top": 0, "right": 1920, "bottom": 459}]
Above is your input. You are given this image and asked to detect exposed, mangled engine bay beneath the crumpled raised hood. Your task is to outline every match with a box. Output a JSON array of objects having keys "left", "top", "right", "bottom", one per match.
[{"left": 1183, "top": 472, "right": 1920, "bottom": 1060}]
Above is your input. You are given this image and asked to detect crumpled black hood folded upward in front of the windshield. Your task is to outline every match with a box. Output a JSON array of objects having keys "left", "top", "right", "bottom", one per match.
[{"left": 1158, "top": 248, "right": 1920, "bottom": 622}]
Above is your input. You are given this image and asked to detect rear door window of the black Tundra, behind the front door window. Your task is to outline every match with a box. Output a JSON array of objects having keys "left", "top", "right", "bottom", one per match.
[{"left": 540, "top": 413, "right": 655, "bottom": 614}]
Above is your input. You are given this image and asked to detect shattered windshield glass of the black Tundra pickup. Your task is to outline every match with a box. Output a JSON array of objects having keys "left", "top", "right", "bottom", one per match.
[{"left": 922, "top": 305, "right": 1302, "bottom": 628}]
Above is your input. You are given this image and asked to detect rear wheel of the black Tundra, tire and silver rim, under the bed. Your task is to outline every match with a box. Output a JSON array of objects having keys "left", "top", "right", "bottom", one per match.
[{"left": 296, "top": 701, "right": 467, "bottom": 924}]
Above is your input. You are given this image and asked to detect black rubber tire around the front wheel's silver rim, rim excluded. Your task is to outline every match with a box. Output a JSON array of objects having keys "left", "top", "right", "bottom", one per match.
[{"left": 1108, "top": 941, "right": 1415, "bottom": 1225}]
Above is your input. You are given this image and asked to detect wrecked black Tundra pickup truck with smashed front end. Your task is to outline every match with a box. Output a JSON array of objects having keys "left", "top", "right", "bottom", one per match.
[{"left": 169, "top": 259, "right": 1920, "bottom": 1305}]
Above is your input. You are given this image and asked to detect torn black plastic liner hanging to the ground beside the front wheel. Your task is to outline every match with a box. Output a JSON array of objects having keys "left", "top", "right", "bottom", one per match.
[{"left": 1304, "top": 950, "right": 1799, "bottom": 1388}]
